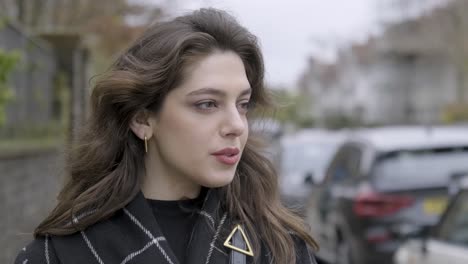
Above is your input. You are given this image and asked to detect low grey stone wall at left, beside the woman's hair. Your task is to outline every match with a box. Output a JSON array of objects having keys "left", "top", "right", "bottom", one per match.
[{"left": 0, "top": 149, "right": 64, "bottom": 263}]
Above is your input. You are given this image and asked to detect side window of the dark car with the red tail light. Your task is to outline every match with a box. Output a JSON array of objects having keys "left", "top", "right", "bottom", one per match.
[{"left": 327, "top": 145, "right": 362, "bottom": 182}]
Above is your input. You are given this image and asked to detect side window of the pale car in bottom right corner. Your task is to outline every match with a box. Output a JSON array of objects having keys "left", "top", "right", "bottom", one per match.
[{"left": 435, "top": 191, "right": 468, "bottom": 246}]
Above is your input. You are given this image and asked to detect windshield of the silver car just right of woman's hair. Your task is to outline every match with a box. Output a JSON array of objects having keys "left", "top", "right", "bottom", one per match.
[{"left": 281, "top": 142, "right": 337, "bottom": 181}]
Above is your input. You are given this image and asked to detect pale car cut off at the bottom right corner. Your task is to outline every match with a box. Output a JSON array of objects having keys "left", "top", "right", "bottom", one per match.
[{"left": 395, "top": 174, "right": 468, "bottom": 264}]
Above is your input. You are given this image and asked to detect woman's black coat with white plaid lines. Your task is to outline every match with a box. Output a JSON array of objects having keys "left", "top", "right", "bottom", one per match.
[{"left": 15, "top": 190, "right": 316, "bottom": 264}]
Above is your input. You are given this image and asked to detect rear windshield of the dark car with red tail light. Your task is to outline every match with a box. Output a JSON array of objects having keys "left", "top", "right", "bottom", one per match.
[{"left": 372, "top": 147, "right": 468, "bottom": 189}]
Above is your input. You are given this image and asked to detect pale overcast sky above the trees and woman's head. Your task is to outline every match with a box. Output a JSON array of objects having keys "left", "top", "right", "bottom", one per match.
[{"left": 159, "top": 0, "right": 378, "bottom": 87}]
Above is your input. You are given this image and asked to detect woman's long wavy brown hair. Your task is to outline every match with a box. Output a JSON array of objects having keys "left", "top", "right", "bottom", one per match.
[{"left": 34, "top": 9, "right": 317, "bottom": 263}]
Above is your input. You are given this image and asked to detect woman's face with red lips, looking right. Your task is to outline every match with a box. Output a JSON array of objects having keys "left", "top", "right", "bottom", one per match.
[{"left": 149, "top": 51, "right": 251, "bottom": 192}]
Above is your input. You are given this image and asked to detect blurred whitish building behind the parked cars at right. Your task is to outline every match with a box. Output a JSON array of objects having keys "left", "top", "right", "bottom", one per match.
[{"left": 300, "top": 0, "right": 460, "bottom": 126}]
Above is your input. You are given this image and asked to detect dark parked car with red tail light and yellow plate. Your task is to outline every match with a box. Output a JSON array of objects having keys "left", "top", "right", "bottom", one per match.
[{"left": 305, "top": 127, "right": 468, "bottom": 264}]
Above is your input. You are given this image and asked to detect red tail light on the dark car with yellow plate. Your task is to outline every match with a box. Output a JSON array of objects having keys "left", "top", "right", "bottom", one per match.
[{"left": 353, "top": 192, "right": 414, "bottom": 217}]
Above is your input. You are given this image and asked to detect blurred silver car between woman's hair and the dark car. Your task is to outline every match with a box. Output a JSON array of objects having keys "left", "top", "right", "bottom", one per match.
[{"left": 279, "top": 129, "right": 344, "bottom": 214}]
